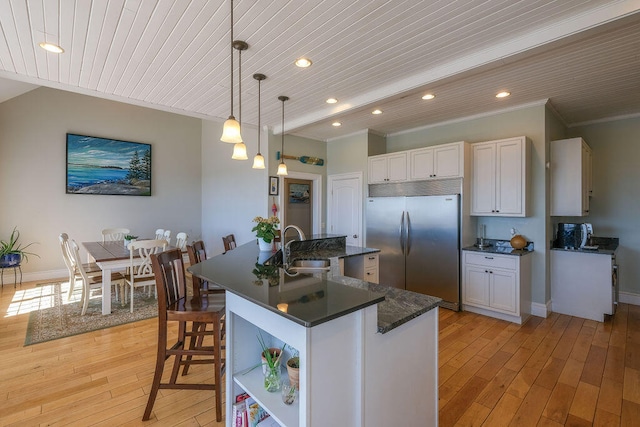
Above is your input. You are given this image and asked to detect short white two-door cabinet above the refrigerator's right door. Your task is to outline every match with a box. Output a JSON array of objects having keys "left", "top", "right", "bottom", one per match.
[{"left": 409, "top": 142, "right": 464, "bottom": 181}]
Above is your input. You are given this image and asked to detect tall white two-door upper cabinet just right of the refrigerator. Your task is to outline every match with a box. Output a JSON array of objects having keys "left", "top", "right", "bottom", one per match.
[{"left": 471, "top": 136, "right": 530, "bottom": 216}]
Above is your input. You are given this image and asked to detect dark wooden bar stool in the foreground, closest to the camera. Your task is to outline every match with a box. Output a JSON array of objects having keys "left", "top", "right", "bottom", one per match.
[{"left": 142, "top": 248, "right": 225, "bottom": 421}]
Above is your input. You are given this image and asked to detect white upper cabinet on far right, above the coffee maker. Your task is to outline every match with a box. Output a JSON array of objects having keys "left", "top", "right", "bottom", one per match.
[{"left": 550, "top": 138, "right": 592, "bottom": 216}]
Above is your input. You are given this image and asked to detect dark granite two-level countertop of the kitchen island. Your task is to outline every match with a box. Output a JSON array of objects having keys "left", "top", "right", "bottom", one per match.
[{"left": 189, "top": 242, "right": 441, "bottom": 333}]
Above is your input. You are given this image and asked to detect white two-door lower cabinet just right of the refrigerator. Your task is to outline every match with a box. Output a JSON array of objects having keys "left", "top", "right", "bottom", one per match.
[{"left": 462, "top": 251, "right": 531, "bottom": 324}]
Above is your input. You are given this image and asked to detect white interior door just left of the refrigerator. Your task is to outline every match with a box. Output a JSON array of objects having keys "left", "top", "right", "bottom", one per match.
[{"left": 327, "top": 173, "right": 363, "bottom": 246}]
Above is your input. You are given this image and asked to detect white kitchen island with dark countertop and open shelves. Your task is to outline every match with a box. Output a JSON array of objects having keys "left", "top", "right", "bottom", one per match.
[{"left": 189, "top": 243, "right": 440, "bottom": 427}]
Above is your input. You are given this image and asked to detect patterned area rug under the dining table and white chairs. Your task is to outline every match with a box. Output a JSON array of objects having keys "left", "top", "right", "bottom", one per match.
[{"left": 24, "top": 282, "right": 158, "bottom": 346}]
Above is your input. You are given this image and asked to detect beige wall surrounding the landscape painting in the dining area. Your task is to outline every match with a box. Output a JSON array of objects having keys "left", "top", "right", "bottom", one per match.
[{"left": 0, "top": 87, "right": 201, "bottom": 280}]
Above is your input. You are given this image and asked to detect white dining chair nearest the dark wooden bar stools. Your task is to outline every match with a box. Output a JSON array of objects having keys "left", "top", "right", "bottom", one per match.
[{"left": 125, "top": 239, "right": 169, "bottom": 313}]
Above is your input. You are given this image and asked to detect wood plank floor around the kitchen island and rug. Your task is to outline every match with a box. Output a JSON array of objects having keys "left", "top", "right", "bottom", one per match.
[{"left": 0, "top": 283, "right": 640, "bottom": 427}]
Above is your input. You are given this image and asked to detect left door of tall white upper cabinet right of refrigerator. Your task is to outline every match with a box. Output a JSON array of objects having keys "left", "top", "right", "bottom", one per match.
[{"left": 471, "top": 144, "right": 496, "bottom": 215}]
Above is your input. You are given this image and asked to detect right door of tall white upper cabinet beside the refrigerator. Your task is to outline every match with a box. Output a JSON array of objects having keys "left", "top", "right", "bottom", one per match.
[{"left": 495, "top": 139, "right": 524, "bottom": 215}]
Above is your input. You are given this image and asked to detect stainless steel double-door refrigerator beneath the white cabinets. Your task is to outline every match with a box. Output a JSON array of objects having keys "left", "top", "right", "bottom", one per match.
[{"left": 366, "top": 194, "right": 460, "bottom": 310}]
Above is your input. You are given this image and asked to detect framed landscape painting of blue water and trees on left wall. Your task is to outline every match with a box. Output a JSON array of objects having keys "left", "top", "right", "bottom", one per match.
[{"left": 66, "top": 133, "right": 151, "bottom": 196}]
